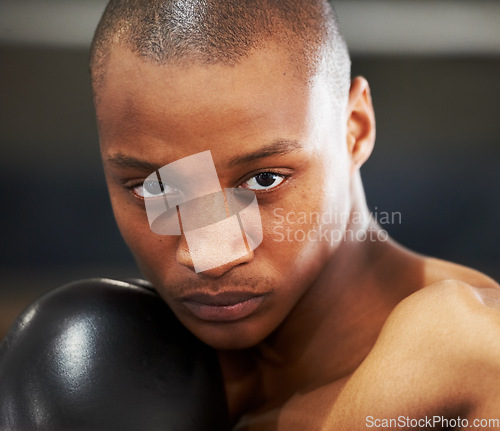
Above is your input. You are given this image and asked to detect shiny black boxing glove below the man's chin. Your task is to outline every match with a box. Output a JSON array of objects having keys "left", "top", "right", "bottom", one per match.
[{"left": 0, "top": 279, "right": 229, "bottom": 431}]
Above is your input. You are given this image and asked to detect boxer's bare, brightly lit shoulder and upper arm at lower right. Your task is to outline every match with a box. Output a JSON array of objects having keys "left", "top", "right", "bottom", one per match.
[{"left": 325, "top": 266, "right": 500, "bottom": 429}]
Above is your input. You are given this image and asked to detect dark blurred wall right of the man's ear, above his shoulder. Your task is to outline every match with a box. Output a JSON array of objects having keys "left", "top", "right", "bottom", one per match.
[{"left": 353, "top": 57, "right": 500, "bottom": 280}]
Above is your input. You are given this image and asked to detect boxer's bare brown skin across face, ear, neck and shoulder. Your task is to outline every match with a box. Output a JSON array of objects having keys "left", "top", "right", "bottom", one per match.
[{"left": 96, "top": 45, "right": 500, "bottom": 431}]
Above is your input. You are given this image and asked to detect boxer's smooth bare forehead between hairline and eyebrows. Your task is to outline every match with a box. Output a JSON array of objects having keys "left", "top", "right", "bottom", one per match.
[{"left": 96, "top": 47, "right": 331, "bottom": 164}]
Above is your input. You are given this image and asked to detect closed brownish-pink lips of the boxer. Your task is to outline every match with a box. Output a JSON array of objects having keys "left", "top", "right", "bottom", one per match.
[{"left": 181, "top": 292, "right": 264, "bottom": 322}]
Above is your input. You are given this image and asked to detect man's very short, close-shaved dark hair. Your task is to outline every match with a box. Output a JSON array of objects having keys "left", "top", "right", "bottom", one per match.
[{"left": 90, "top": 0, "right": 350, "bottom": 106}]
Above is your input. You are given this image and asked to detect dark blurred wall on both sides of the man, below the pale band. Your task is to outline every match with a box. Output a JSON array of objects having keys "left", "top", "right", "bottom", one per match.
[{"left": 0, "top": 46, "right": 500, "bottom": 337}]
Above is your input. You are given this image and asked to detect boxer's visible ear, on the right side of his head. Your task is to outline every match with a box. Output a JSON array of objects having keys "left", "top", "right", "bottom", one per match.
[{"left": 346, "top": 77, "right": 375, "bottom": 173}]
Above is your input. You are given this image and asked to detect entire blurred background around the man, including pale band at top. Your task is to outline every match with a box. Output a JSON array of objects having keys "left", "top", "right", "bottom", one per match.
[{"left": 0, "top": 0, "right": 500, "bottom": 339}]
